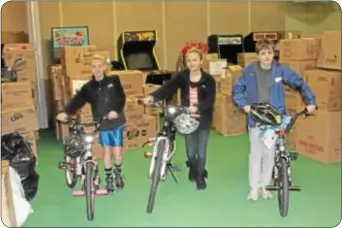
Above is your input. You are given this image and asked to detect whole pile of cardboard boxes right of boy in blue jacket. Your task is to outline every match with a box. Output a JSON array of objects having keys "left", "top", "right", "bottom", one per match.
[{"left": 280, "top": 31, "right": 341, "bottom": 163}]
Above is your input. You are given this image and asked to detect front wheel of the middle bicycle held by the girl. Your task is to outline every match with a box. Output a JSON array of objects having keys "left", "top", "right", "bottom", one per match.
[{"left": 146, "top": 140, "right": 165, "bottom": 213}]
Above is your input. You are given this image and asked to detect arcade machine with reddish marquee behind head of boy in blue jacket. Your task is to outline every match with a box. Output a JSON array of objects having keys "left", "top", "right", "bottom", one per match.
[{"left": 243, "top": 32, "right": 280, "bottom": 59}]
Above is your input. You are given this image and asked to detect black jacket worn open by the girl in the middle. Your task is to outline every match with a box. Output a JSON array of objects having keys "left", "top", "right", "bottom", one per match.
[{"left": 150, "top": 70, "right": 216, "bottom": 129}]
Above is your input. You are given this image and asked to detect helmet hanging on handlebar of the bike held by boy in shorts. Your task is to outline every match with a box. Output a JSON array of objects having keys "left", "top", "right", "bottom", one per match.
[{"left": 64, "top": 135, "right": 85, "bottom": 158}]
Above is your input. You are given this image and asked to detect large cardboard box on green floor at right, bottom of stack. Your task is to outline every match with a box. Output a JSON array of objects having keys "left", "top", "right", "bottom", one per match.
[{"left": 297, "top": 110, "right": 341, "bottom": 163}]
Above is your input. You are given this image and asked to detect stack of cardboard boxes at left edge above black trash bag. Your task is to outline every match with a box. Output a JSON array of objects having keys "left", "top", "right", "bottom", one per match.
[{"left": 1, "top": 44, "right": 39, "bottom": 158}]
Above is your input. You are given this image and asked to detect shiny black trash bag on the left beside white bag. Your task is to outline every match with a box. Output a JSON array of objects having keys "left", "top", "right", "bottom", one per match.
[{"left": 1, "top": 133, "right": 39, "bottom": 201}]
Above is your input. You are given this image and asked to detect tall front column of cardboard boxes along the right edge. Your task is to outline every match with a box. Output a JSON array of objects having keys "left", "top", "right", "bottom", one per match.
[{"left": 297, "top": 31, "right": 341, "bottom": 163}]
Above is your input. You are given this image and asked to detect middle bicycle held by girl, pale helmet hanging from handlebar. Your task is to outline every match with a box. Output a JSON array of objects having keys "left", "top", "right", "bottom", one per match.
[{"left": 138, "top": 100, "right": 199, "bottom": 213}]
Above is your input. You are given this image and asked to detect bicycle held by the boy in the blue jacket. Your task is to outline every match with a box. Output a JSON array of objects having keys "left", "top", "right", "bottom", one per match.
[{"left": 252, "top": 105, "right": 317, "bottom": 217}]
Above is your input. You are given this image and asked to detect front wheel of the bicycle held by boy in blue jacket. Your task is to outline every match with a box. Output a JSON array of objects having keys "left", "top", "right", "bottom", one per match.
[{"left": 278, "top": 158, "right": 290, "bottom": 217}]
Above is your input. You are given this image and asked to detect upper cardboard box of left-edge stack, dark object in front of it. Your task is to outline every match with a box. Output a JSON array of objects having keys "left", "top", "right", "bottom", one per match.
[{"left": 3, "top": 45, "right": 36, "bottom": 82}]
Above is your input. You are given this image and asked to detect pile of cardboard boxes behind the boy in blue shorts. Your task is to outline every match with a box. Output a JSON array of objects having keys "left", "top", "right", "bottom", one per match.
[{"left": 50, "top": 45, "right": 160, "bottom": 159}]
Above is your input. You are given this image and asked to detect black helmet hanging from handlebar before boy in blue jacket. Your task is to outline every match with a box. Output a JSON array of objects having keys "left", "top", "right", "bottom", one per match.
[{"left": 250, "top": 103, "right": 282, "bottom": 126}]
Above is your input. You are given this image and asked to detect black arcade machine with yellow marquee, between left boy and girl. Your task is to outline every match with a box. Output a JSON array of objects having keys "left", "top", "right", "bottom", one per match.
[{"left": 117, "top": 30, "right": 171, "bottom": 85}]
